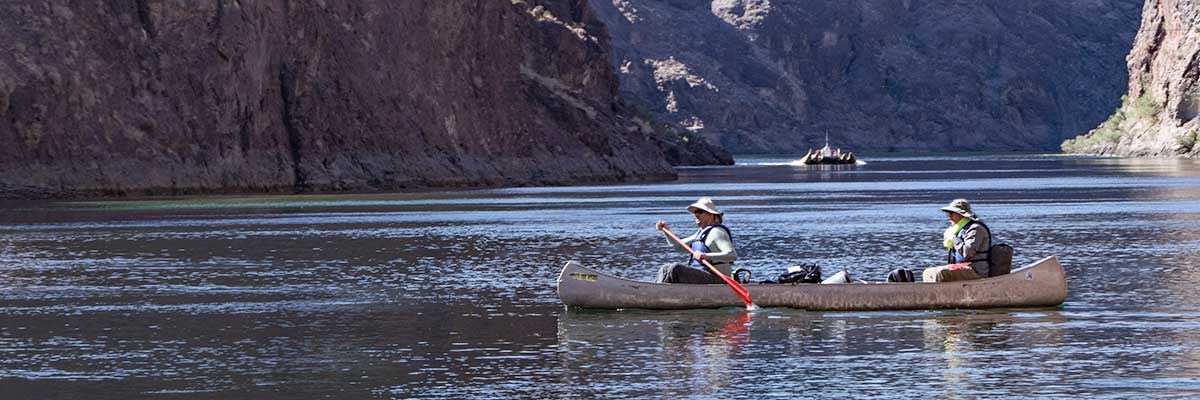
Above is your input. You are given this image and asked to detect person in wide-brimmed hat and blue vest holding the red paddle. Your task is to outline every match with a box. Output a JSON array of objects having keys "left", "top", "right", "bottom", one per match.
[{"left": 654, "top": 197, "right": 738, "bottom": 283}]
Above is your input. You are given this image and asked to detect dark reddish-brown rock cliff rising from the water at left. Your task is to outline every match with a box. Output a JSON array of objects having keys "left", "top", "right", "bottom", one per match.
[{"left": 0, "top": 0, "right": 727, "bottom": 197}]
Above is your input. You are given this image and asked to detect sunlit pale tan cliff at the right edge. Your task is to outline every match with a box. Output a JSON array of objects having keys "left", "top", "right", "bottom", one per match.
[{"left": 1062, "top": 0, "right": 1200, "bottom": 157}]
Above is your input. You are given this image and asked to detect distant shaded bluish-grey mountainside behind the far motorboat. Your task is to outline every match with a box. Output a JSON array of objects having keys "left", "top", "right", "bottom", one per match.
[{"left": 592, "top": 0, "right": 1141, "bottom": 153}]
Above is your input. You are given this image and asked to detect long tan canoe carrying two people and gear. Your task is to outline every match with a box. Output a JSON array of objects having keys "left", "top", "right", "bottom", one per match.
[{"left": 558, "top": 256, "right": 1067, "bottom": 311}]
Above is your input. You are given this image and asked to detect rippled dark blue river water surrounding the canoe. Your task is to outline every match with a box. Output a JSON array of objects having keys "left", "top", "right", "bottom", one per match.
[{"left": 0, "top": 155, "right": 1200, "bottom": 399}]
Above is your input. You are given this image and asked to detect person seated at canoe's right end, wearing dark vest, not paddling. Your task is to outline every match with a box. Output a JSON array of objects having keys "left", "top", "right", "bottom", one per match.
[{"left": 922, "top": 198, "right": 991, "bottom": 282}]
